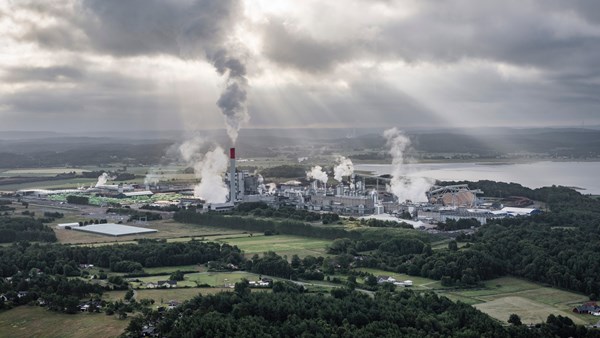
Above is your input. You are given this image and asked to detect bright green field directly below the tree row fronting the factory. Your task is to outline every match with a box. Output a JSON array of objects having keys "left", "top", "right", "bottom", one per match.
[{"left": 213, "top": 235, "right": 331, "bottom": 259}]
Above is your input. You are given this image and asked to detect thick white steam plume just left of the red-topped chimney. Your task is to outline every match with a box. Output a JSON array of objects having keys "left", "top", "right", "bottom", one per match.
[{"left": 179, "top": 137, "right": 229, "bottom": 203}]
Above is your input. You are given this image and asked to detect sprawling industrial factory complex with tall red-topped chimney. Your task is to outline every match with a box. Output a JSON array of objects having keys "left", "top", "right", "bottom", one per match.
[{"left": 12, "top": 148, "right": 540, "bottom": 230}]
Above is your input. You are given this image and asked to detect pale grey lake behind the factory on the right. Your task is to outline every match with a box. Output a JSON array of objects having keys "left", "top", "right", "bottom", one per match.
[{"left": 355, "top": 161, "right": 600, "bottom": 195}]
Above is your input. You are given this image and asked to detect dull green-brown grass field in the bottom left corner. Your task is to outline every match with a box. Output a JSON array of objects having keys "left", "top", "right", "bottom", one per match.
[{"left": 0, "top": 306, "right": 129, "bottom": 338}]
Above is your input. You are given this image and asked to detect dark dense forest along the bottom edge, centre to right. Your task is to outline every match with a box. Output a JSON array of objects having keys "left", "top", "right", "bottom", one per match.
[{"left": 125, "top": 282, "right": 600, "bottom": 338}]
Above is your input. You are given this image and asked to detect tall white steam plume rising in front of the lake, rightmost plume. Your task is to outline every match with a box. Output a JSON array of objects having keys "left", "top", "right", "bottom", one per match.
[{"left": 383, "top": 128, "right": 433, "bottom": 202}]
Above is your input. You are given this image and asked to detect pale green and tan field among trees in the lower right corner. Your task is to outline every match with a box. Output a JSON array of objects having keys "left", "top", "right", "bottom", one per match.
[{"left": 436, "top": 277, "right": 598, "bottom": 324}]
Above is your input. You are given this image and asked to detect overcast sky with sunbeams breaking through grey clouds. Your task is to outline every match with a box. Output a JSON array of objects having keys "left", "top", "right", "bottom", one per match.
[{"left": 0, "top": 0, "right": 600, "bottom": 134}]
